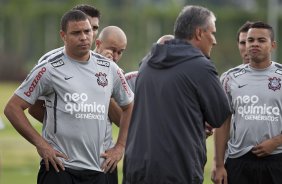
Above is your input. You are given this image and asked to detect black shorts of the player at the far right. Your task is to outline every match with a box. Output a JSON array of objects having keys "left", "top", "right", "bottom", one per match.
[{"left": 225, "top": 152, "right": 282, "bottom": 184}]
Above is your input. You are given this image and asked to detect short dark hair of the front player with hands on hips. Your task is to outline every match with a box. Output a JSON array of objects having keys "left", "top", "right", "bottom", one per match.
[{"left": 61, "top": 10, "right": 88, "bottom": 32}]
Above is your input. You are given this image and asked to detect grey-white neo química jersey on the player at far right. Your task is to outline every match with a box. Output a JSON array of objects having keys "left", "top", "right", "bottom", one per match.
[{"left": 221, "top": 62, "right": 282, "bottom": 158}]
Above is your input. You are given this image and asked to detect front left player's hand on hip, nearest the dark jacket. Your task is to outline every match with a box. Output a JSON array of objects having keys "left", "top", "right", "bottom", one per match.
[{"left": 101, "top": 144, "right": 124, "bottom": 173}]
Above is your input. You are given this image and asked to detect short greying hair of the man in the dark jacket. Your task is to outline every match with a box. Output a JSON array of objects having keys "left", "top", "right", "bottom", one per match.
[{"left": 174, "top": 6, "right": 216, "bottom": 40}]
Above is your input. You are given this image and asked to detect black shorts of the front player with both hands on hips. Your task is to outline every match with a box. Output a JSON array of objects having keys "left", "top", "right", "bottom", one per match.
[{"left": 37, "top": 163, "right": 118, "bottom": 184}]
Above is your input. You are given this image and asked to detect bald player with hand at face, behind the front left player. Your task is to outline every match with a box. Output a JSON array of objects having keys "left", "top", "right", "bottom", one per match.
[{"left": 29, "top": 23, "right": 127, "bottom": 181}]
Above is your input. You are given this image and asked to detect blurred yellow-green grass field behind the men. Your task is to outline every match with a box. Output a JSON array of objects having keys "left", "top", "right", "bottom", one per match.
[{"left": 0, "top": 82, "right": 213, "bottom": 184}]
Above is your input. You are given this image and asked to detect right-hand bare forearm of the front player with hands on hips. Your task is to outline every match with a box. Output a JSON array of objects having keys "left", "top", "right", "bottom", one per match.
[{"left": 114, "top": 103, "right": 133, "bottom": 147}]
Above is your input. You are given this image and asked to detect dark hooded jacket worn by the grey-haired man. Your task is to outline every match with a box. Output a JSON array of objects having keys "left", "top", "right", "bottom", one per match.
[{"left": 123, "top": 40, "right": 230, "bottom": 184}]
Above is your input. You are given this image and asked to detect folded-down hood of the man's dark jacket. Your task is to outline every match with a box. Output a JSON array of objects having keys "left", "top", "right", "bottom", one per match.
[{"left": 142, "top": 39, "right": 205, "bottom": 69}]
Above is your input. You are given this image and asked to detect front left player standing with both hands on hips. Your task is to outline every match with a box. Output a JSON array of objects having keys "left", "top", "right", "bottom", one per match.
[{"left": 4, "top": 10, "right": 134, "bottom": 184}]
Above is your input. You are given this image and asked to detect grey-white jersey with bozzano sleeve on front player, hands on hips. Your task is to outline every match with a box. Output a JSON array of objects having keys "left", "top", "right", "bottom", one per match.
[{"left": 15, "top": 50, "right": 134, "bottom": 171}]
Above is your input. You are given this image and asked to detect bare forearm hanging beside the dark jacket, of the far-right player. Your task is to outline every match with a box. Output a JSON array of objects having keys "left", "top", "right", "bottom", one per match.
[{"left": 214, "top": 117, "right": 230, "bottom": 167}]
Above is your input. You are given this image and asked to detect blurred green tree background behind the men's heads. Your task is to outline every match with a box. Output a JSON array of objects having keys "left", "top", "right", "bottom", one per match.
[{"left": 0, "top": 0, "right": 282, "bottom": 81}]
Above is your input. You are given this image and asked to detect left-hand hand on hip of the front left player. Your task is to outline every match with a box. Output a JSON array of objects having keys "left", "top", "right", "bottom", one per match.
[{"left": 36, "top": 141, "right": 68, "bottom": 172}]
